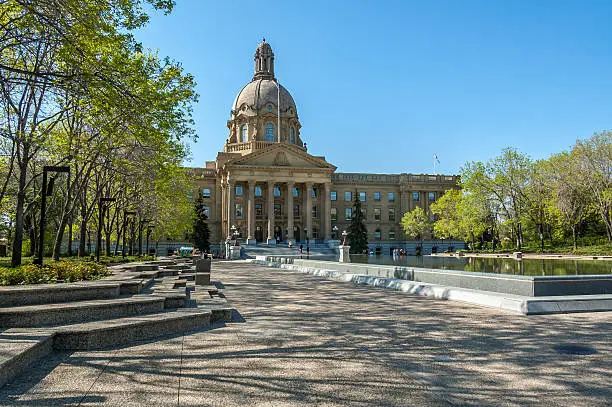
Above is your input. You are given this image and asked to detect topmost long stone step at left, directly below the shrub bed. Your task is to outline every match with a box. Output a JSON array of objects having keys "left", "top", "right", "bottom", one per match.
[{"left": 0, "top": 280, "right": 122, "bottom": 307}]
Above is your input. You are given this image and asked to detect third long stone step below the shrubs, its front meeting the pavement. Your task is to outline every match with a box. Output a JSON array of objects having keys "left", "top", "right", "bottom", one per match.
[{"left": 53, "top": 308, "right": 212, "bottom": 350}]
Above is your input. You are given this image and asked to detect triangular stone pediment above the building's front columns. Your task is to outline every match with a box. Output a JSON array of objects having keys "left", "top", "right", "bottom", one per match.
[{"left": 228, "top": 144, "right": 336, "bottom": 170}]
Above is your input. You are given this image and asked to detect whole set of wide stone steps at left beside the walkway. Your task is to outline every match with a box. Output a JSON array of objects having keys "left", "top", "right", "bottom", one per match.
[{"left": 0, "top": 260, "right": 232, "bottom": 387}]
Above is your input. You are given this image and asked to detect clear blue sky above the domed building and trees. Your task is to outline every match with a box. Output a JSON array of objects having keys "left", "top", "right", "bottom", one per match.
[{"left": 137, "top": 0, "right": 612, "bottom": 173}]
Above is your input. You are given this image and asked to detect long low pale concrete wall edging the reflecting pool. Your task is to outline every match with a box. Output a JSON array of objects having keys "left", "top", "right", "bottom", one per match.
[{"left": 258, "top": 256, "right": 612, "bottom": 297}]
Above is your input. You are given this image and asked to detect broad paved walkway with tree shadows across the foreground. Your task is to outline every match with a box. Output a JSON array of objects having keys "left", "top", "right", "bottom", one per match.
[{"left": 0, "top": 263, "right": 612, "bottom": 407}]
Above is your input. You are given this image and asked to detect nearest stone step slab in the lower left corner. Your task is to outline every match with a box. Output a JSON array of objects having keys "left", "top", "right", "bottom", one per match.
[{"left": 0, "top": 329, "right": 53, "bottom": 387}]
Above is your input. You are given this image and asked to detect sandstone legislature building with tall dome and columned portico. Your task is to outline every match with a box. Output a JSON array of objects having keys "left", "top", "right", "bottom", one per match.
[{"left": 189, "top": 40, "right": 458, "bottom": 251}]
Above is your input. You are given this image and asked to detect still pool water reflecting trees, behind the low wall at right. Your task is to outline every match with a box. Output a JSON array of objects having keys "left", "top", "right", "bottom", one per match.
[{"left": 351, "top": 254, "right": 612, "bottom": 276}]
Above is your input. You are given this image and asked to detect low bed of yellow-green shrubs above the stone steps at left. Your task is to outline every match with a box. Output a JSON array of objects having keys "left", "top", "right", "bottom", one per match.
[{"left": 0, "top": 261, "right": 110, "bottom": 285}]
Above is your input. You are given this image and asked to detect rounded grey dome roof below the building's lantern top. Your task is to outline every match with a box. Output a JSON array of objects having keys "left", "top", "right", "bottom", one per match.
[{"left": 232, "top": 79, "right": 297, "bottom": 116}]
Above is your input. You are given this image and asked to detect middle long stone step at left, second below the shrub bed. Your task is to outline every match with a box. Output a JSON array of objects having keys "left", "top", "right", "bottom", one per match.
[{"left": 0, "top": 295, "right": 166, "bottom": 328}]
